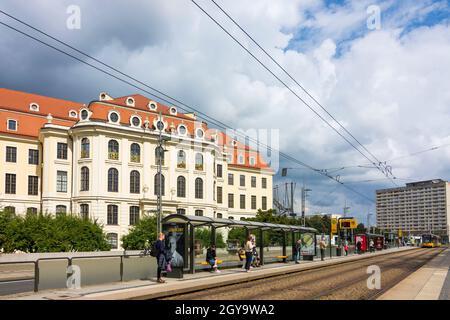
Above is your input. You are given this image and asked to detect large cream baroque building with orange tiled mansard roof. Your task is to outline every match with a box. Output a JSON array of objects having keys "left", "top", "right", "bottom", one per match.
[{"left": 0, "top": 89, "right": 273, "bottom": 248}]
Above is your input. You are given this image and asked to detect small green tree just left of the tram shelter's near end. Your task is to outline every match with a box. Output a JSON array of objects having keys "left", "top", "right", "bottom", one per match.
[{"left": 122, "top": 216, "right": 157, "bottom": 250}]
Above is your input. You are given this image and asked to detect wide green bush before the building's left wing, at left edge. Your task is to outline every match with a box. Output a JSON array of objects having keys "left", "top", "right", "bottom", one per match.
[{"left": 0, "top": 212, "right": 111, "bottom": 253}]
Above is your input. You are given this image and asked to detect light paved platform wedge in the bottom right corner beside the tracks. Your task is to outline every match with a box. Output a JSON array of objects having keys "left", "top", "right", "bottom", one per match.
[{"left": 378, "top": 248, "right": 450, "bottom": 300}]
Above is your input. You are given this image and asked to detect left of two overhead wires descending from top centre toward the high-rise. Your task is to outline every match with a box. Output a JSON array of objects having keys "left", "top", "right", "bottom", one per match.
[{"left": 191, "top": 0, "right": 397, "bottom": 186}]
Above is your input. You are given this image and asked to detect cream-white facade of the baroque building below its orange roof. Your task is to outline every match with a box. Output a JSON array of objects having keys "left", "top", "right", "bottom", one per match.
[{"left": 0, "top": 89, "right": 273, "bottom": 247}]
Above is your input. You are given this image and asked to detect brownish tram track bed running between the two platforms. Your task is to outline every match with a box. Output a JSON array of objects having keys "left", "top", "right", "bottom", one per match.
[{"left": 165, "top": 249, "right": 442, "bottom": 300}]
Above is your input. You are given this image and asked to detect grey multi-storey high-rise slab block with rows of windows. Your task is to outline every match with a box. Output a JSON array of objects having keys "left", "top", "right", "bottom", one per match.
[{"left": 376, "top": 179, "right": 450, "bottom": 237}]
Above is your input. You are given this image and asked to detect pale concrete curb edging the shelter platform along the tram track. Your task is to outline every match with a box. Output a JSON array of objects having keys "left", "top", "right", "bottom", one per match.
[{"left": 73, "top": 247, "right": 418, "bottom": 300}]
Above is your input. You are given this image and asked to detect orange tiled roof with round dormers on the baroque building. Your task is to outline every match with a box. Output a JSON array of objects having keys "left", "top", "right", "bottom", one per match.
[{"left": 0, "top": 88, "right": 269, "bottom": 169}]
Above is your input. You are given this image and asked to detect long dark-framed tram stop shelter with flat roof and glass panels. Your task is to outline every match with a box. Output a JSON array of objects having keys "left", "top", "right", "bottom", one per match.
[{"left": 161, "top": 214, "right": 318, "bottom": 273}]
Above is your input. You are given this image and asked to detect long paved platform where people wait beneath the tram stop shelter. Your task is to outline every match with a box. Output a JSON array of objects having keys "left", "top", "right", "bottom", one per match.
[{"left": 0, "top": 247, "right": 416, "bottom": 300}]
